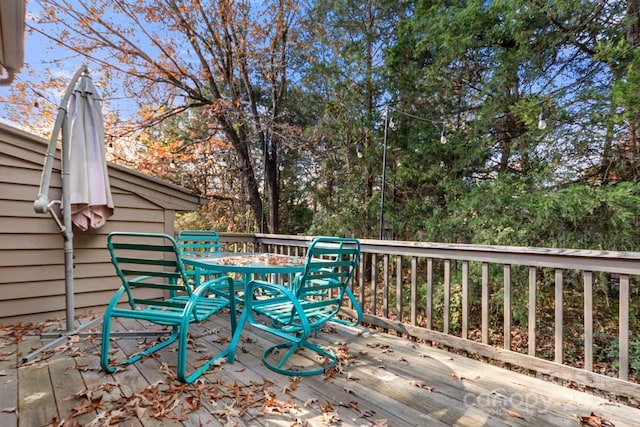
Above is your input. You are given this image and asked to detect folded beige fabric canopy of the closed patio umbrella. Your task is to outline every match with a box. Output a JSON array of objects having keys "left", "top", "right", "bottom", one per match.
[{"left": 69, "top": 74, "right": 113, "bottom": 231}]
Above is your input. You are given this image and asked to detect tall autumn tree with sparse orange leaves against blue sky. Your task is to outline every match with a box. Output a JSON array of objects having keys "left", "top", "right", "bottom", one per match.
[{"left": 17, "top": 0, "right": 304, "bottom": 233}]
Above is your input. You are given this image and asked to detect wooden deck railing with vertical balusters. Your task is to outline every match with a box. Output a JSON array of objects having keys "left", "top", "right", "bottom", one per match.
[{"left": 221, "top": 233, "right": 640, "bottom": 398}]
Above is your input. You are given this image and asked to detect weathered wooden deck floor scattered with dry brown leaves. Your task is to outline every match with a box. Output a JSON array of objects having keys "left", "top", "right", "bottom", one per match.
[{"left": 0, "top": 316, "right": 640, "bottom": 427}]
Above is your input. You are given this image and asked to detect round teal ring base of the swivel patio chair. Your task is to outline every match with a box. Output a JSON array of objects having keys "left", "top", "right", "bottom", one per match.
[{"left": 262, "top": 341, "right": 338, "bottom": 377}]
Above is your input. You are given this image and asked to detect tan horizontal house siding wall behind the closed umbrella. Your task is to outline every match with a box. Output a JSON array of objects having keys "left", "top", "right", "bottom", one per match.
[{"left": 0, "top": 123, "right": 200, "bottom": 324}]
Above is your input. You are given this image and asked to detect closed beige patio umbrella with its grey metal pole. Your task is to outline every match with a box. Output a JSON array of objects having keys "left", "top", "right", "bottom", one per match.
[{"left": 32, "top": 65, "right": 113, "bottom": 342}]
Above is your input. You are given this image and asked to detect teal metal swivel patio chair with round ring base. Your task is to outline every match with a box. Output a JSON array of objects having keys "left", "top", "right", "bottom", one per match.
[{"left": 229, "top": 237, "right": 362, "bottom": 376}]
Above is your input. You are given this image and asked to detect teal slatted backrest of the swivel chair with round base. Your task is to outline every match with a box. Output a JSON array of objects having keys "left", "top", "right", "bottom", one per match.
[{"left": 296, "top": 237, "right": 360, "bottom": 300}]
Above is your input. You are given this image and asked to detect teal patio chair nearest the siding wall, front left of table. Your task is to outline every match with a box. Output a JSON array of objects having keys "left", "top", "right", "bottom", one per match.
[{"left": 100, "top": 232, "right": 236, "bottom": 383}]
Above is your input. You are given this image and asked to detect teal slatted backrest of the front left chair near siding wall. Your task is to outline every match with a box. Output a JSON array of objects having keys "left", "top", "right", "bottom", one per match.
[{"left": 107, "top": 232, "right": 192, "bottom": 309}]
